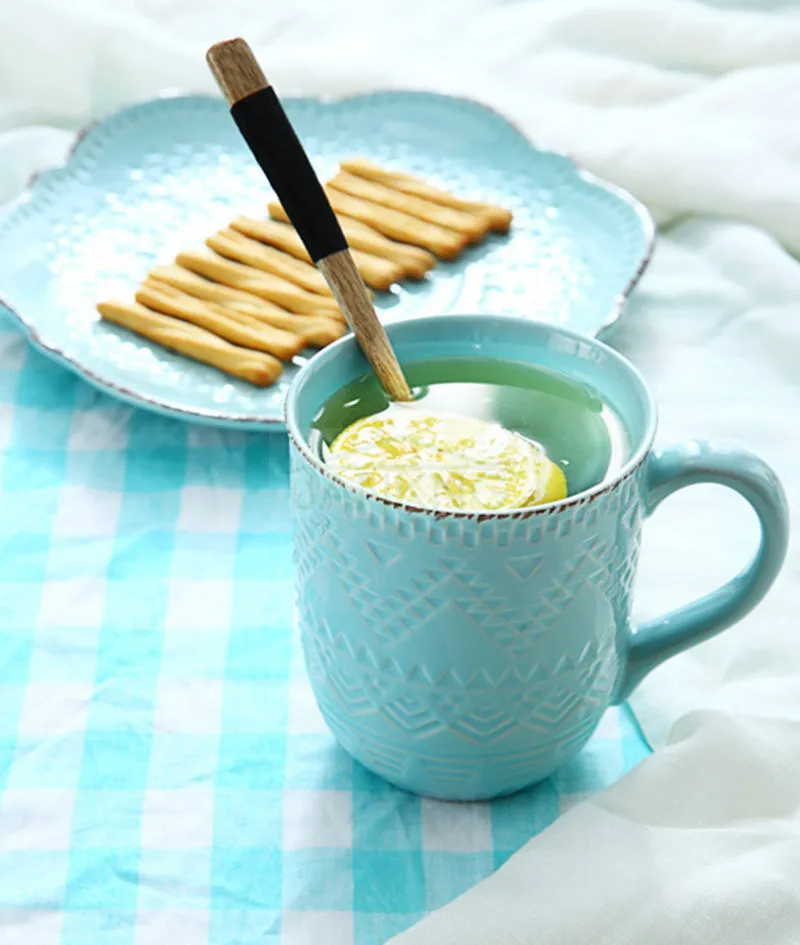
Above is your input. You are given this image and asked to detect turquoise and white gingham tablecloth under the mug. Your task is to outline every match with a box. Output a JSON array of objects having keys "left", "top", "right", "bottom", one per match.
[{"left": 0, "top": 316, "right": 647, "bottom": 945}]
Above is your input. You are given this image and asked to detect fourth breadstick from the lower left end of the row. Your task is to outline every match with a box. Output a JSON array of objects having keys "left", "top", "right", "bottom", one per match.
[{"left": 176, "top": 251, "right": 344, "bottom": 321}]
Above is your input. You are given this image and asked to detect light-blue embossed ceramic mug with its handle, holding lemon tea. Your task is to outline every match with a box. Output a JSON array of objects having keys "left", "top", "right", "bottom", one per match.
[{"left": 286, "top": 315, "right": 788, "bottom": 800}]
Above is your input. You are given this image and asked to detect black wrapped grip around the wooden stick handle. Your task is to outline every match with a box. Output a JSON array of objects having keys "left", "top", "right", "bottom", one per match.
[{"left": 231, "top": 87, "right": 347, "bottom": 262}]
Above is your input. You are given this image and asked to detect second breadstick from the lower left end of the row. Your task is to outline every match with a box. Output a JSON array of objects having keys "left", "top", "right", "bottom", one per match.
[{"left": 136, "top": 285, "right": 305, "bottom": 361}]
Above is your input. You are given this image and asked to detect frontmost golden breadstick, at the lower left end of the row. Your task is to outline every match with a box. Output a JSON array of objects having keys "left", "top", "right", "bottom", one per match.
[{"left": 97, "top": 299, "right": 281, "bottom": 387}]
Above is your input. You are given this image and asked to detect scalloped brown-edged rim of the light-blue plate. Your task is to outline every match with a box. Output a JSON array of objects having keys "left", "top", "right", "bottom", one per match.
[{"left": 0, "top": 88, "right": 657, "bottom": 433}]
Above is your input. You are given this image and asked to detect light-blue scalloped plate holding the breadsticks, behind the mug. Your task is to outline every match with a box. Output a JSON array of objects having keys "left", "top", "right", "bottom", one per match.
[{"left": 0, "top": 92, "right": 654, "bottom": 428}]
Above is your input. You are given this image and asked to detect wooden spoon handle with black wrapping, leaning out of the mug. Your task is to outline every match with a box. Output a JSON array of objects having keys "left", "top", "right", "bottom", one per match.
[{"left": 206, "top": 39, "right": 411, "bottom": 400}]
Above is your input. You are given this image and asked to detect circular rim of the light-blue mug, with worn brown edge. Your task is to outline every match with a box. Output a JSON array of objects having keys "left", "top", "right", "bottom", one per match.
[{"left": 284, "top": 312, "right": 658, "bottom": 521}]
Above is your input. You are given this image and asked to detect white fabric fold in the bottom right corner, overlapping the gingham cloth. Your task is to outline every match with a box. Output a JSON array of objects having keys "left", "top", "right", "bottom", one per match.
[{"left": 395, "top": 713, "right": 800, "bottom": 945}]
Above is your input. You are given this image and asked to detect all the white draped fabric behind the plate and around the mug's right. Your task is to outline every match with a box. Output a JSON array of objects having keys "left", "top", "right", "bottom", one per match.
[{"left": 0, "top": 0, "right": 800, "bottom": 945}]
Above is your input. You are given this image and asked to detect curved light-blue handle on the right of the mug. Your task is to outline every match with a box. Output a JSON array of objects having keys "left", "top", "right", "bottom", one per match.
[{"left": 614, "top": 442, "right": 789, "bottom": 704}]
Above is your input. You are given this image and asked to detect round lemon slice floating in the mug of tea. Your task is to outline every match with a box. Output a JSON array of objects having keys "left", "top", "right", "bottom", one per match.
[{"left": 328, "top": 404, "right": 567, "bottom": 511}]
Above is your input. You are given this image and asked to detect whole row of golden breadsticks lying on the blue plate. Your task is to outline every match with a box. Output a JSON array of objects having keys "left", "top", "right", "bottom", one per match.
[{"left": 97, "top": 160, "right": 511, "bottom": 387}]
